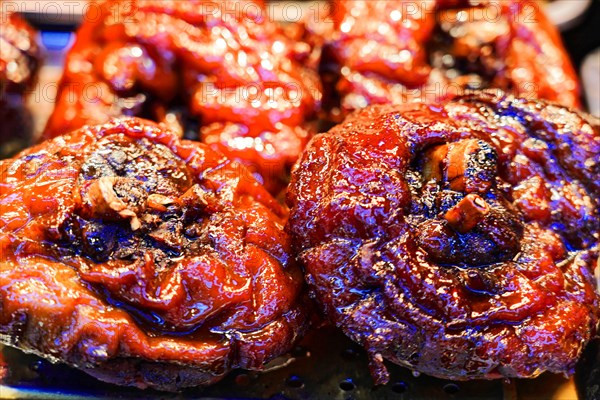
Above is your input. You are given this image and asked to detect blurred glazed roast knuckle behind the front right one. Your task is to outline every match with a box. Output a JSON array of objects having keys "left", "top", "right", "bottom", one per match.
[{"left": 321, "top": 0, "right": 579, "bottom": 120}]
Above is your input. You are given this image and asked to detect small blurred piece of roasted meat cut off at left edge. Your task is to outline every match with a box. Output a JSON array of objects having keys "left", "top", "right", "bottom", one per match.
[{"left": 0, "top": 7, "right": 41, "bottom": 158}]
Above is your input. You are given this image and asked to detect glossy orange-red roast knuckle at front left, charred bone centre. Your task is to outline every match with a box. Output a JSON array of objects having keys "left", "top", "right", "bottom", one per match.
[{"left": 0, "top": 118, "right": 306, "bottom": 390}]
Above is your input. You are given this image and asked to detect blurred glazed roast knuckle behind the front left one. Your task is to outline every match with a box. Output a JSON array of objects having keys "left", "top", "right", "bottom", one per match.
[{"left": 45, "top": 0, "right": 321, "bottom": 193}]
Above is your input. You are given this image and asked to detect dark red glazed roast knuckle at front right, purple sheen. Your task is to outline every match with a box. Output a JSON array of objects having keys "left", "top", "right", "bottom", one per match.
[{"left": 287, "top": 91, "right": 600, "bottom": 383}]
